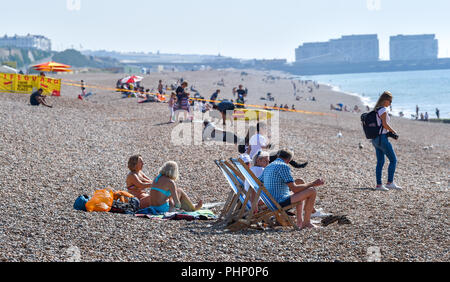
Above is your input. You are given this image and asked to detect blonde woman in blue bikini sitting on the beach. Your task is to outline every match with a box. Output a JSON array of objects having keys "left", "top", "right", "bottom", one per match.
[{"left": 150, "top": 161, "right": 203, "bottom": 213}]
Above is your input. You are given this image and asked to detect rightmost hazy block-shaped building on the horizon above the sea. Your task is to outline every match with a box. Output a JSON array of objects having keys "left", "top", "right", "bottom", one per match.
[{"left": 389, "top": 34, "right": 438, "bottom": 61}]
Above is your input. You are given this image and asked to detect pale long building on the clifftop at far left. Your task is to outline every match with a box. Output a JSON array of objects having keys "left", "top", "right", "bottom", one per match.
[{"left": 0, "top": 34, "right": 52, "bottom": 51}]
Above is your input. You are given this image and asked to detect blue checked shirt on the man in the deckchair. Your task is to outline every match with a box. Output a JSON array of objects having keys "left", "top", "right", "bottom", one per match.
[{"left": 259, "top": 158, "right": 294, "bottom": 203}]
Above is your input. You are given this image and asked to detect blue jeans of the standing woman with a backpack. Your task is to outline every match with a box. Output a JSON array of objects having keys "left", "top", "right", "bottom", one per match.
[{"left": 372, "top": 134, "right": 397, "bottom": 185}]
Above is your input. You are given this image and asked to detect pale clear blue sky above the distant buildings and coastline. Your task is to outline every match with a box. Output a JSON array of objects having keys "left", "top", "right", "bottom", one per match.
[{"left": 0, "top": 0, "right": 450, "bottom": 61}]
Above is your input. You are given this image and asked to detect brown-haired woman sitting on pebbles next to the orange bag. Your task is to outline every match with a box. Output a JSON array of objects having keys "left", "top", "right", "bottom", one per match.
[{"left": 126, "top": 155, "right": 152, "bottom": 209}]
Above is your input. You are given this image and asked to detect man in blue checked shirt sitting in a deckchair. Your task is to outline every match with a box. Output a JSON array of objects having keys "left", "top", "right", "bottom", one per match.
[{"left": 259, "top": 150, "right": 324, "bottom": 229}]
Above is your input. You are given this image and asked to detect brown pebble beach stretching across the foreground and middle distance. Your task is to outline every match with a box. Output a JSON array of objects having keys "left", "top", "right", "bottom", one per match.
[{"left": 0, "top": 70, "right": 450, "bottom": 262}]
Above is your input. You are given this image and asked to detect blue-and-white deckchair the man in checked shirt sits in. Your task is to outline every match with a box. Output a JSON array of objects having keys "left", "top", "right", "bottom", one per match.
[{"left": 230, "top": 158, "right": 302, "bottom": 229}]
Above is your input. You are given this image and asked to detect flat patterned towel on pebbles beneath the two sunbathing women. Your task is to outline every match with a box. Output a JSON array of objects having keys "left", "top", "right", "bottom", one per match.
[{"left": 135, "top": 208, "right": 217, "bottom": 221}]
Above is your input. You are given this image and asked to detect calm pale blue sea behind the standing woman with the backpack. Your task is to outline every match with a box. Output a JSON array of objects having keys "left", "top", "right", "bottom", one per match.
[{"left": 302, "top": 70, "right": 450, "bottom": 118}]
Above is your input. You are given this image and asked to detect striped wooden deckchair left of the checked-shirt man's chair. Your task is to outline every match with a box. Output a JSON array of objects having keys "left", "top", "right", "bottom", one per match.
[{"left": 214, "top": 160, "right": 251, "bottom": 225}]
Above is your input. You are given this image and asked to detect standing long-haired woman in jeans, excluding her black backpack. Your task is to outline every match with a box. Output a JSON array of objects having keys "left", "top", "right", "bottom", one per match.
[{"left": 372, "top": 91, "right": 402, "bottom": 191}]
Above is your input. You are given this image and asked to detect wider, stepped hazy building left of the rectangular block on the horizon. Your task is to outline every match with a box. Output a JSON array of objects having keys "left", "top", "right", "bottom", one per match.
[{"left": 295, "top": 34, "right": 379, "bottom": 63}]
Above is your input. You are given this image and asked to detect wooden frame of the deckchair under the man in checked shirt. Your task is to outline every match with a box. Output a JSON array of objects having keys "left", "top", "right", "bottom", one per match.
[{"left": 230, "top": 158, "right": 302, "bottom": 230}]
